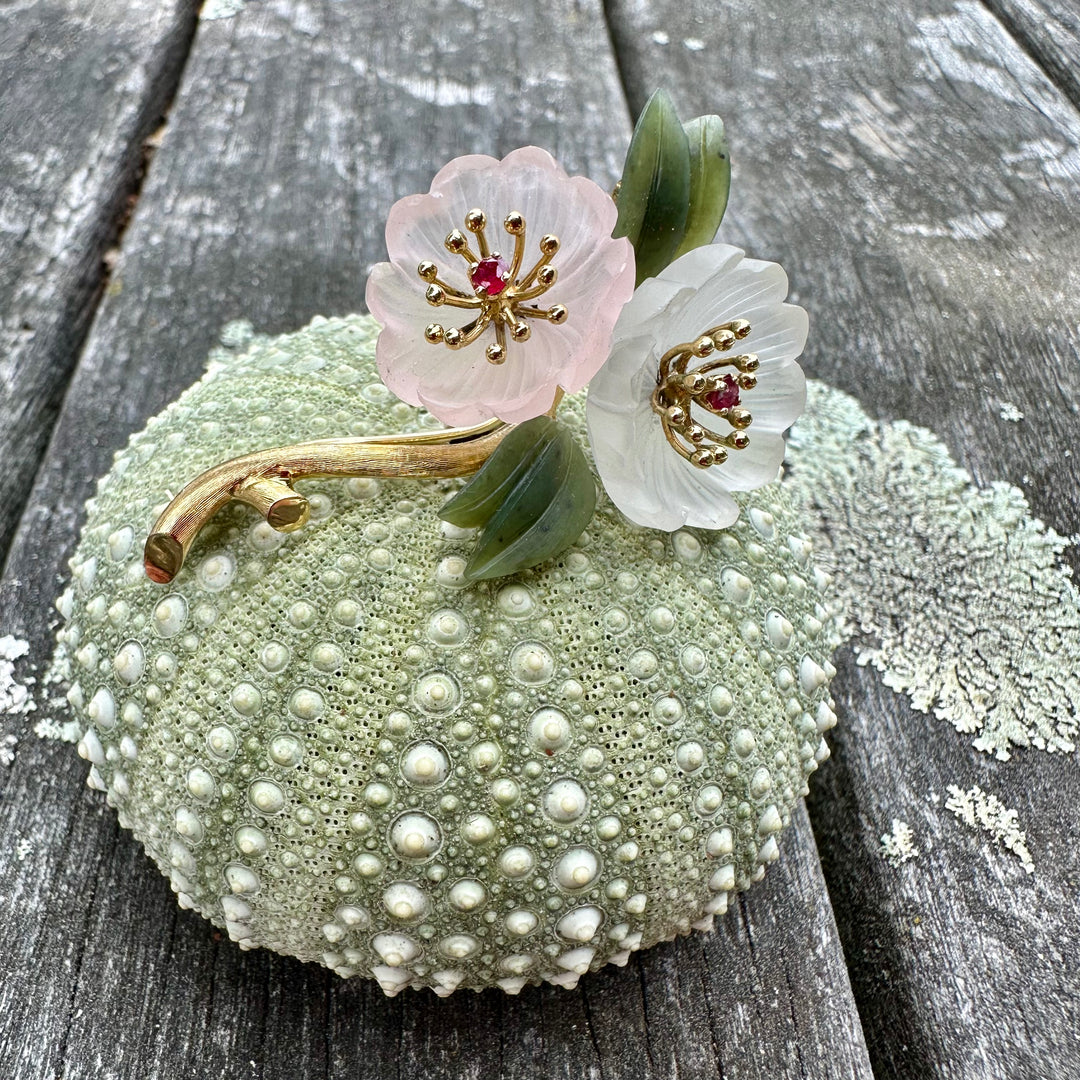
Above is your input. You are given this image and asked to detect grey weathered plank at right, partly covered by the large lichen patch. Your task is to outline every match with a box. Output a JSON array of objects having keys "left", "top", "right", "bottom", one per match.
[{"left": 609, "top": 0, "right": 1080, "bottom": 1080}]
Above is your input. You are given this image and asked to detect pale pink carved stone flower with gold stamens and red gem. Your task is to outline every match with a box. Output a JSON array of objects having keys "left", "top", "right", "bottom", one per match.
[{"left": 366, "top": 146, "right": 634, "bottom": 424}]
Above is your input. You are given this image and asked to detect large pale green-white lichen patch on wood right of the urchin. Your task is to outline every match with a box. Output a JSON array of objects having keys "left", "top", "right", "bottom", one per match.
[{"left": 788, "top": 383, "right": 1080, "bottom": 759}]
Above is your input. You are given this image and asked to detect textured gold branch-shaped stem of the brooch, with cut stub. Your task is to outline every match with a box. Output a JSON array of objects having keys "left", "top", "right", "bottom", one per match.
[{"left": 143, "top": 420, "right": 511, "bottom": 584}]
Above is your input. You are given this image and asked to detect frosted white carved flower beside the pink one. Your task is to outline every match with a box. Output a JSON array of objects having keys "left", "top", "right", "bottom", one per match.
[{"left": 588, "top": 244, "right": 808, "bottom": 530}]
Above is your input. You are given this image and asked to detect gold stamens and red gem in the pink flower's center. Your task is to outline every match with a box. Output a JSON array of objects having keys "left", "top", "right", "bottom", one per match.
[{"left": 417, "top": 210, "right": 567, "bottom": 364}]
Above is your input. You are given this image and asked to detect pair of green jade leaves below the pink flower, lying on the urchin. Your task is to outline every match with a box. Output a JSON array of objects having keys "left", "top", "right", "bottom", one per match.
[{"left": 440, "top": 416, "right": 596, "bottom": 581}]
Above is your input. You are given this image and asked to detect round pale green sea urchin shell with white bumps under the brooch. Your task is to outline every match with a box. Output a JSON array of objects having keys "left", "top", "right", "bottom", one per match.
[{"left": 52, "top": 316, "right": 835, "bottom": 994}]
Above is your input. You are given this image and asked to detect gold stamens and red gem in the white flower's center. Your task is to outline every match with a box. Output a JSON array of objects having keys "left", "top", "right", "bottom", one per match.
[{"left": 652, "top": 319, "right": 758, "bottom": 469}]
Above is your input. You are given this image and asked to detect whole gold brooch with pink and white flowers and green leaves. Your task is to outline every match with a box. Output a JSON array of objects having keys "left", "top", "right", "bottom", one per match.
[{"left": 144, "top": 91, "right": 807, "bottom": 582}]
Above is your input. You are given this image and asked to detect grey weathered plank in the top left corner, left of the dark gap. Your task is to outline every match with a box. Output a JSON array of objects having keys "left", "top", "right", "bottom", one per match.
[{"left": 0, "top": 0, "right": 198, "bottom": 564}]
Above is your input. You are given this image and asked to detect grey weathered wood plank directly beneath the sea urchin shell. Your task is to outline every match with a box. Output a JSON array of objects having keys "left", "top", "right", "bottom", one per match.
[{"left": 0, "top": 0, "right": 869, "bottom": 1080}]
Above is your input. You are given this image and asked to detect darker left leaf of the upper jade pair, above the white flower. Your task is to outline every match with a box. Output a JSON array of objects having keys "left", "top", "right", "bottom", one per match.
[{"left": 611, "top": 90, "right": 690, "bottom": 285}]
